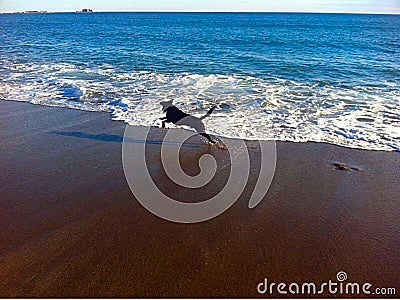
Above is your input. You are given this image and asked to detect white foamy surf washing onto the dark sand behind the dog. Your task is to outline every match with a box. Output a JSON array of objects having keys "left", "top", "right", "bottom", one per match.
[{"left": 0, "top": 61, "right": 400, "bottom": 151}]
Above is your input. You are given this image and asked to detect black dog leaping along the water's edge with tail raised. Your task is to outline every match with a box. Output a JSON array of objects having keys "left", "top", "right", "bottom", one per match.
[{"left": 160, "top": 100, "right": 217, "bottom": 144}]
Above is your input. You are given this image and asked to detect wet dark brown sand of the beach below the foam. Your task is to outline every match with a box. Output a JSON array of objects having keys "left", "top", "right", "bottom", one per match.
[{"left": 0, "top": 101, "right": 400, "bottom": 297}]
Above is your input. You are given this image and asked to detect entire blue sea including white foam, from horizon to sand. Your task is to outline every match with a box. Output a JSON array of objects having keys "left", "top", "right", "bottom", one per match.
[{"left": 0, "top": 13, "right": 400, "bottom": 151}]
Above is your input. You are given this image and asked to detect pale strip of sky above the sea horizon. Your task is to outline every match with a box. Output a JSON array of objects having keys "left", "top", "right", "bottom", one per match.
[{"left": 0, "top": 0, "right": 400, "bottom": 14}]
